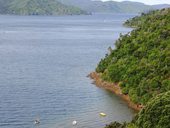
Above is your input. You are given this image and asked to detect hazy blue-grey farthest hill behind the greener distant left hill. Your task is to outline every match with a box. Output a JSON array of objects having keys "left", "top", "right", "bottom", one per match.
[{"left": 59, "top": 0, "right": 152, "bottom": 13}]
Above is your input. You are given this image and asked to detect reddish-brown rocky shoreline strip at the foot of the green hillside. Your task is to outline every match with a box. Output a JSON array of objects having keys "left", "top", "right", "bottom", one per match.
[{"left": 88, "top": 72, "right": 144, "bottom": 112}]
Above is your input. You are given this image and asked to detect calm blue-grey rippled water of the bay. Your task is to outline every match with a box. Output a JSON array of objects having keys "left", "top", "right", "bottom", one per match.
[{"left": 0, "top": 14, "right": 133, "bottom": 128}]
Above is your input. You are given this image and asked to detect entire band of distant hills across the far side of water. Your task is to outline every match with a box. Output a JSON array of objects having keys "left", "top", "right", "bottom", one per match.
[{"left": 0, "top": 0, "right": 170, "bottom": 15}]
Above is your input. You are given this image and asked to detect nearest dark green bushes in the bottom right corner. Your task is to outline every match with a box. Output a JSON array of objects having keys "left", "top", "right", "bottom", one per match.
[{"left": 105, "top": 91, "right": 170, "bottom": 128}]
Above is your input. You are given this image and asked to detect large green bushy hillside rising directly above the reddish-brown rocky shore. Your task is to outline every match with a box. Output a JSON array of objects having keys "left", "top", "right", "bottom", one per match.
[{"left": 96, "top": 9, "right": 170, "bottom": 105}]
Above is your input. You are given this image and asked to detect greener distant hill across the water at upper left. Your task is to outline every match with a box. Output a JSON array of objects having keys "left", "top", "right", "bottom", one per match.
[{"left": 0, "top": 0, "right": 87, "bottom": 15}]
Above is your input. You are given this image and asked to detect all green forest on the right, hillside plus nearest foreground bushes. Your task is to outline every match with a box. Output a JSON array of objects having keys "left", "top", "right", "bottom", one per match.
[{"left": 96, "top": 8, "right": 170, "bottom": 128}]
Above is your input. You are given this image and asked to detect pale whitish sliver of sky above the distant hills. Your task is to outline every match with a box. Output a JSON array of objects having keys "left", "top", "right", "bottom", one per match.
[{"left": 102, "top": 0, "right": 170, "bottom": 5}]
